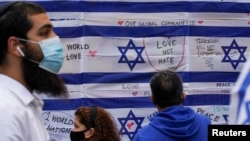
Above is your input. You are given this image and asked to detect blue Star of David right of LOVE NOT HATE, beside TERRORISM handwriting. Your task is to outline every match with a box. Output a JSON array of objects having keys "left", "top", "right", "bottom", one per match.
[{"left": 221, "top": 39, "right": 247, "bottom": 70}]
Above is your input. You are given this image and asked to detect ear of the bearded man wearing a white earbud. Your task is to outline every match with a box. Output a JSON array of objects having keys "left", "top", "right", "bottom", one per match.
[{"left": 7, "top": 36, "right": 21, "bottom": 56}]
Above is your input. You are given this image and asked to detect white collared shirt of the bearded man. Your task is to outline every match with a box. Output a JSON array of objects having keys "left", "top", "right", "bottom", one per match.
[{"left": 0, "top": 74, "right": 49, "bottom": 141}]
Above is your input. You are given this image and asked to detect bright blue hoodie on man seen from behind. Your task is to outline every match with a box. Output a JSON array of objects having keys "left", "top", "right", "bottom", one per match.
[{"left": 133, "top": 106, "right": 211, "bottom": 141}]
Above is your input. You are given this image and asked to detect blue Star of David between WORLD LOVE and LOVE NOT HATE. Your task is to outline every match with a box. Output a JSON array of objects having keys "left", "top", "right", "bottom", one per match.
[{"left": 118, "top": 39, "right": 145, "bottom": 71}]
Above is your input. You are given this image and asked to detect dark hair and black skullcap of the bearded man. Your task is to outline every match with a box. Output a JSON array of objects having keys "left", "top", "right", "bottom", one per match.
[{"left": 0, "top": 2, "right": 46, "bottom": 65}]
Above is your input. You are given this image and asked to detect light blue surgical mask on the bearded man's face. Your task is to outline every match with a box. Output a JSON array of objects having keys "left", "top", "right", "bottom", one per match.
[{"left": 17, "top": 36, "right": 64, "bottom": 74}]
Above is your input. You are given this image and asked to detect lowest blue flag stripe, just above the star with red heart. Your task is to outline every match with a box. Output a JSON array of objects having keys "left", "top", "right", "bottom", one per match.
[{"left": 43, "top": 94, "right": 229, "bottom": 110}]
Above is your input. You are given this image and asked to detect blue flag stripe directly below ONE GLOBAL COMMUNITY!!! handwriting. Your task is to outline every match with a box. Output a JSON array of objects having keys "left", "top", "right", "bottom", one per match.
[{"left": 55, "top": 26, "right": 250, "bottom": 38}]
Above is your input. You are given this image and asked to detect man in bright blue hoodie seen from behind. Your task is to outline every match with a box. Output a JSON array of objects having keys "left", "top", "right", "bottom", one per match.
[{"left": 133, "top": 70, "right": 211, "bottom": 141}]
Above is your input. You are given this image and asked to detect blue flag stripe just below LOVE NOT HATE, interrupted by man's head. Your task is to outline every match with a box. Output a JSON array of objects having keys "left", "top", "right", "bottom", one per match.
[{"left": 60, "top": 72, "right": 239, "bottom": 84}]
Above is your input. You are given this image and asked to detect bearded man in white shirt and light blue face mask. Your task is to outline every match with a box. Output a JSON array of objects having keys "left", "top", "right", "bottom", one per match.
[{"left": 0, "top": 2, "right": 68, "bottom": 141}]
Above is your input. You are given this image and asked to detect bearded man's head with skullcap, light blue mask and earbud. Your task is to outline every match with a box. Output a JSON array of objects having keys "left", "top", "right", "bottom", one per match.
[{"left": 0, "top": 2, "right": 67, "bottom": 96}]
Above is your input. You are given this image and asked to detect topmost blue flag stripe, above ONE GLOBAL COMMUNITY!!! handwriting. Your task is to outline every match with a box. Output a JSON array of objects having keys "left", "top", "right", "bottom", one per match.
[{"left": 13, "top": 0, "right": 250, "bottom": 13}]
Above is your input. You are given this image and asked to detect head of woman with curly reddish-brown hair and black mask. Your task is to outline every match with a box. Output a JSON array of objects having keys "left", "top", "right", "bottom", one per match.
[{"left": 70, "top": 106, "right": 120, "bottom": 141}]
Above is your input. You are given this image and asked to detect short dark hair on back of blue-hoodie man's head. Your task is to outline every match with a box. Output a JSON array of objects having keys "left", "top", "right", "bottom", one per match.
[{"left": 150, "top": 70, "right": 183, "bottom": 108}]
